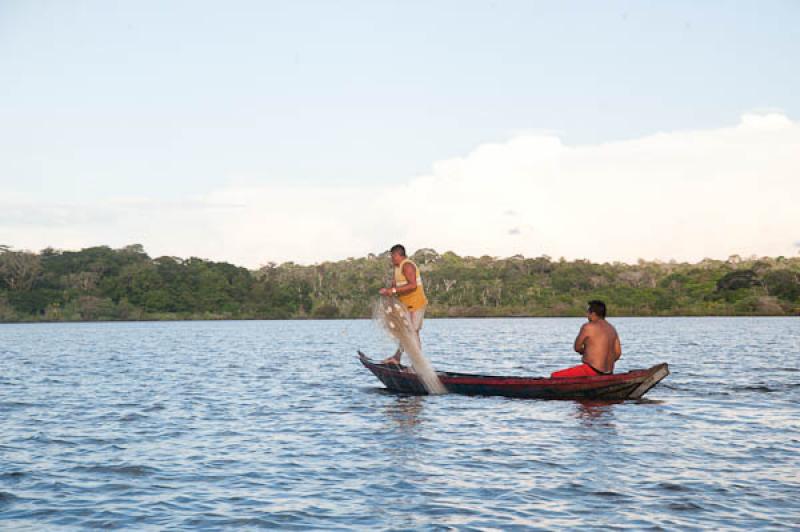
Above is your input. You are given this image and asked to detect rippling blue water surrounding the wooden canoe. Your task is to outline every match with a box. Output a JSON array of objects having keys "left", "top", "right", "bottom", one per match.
[{"left": 0, "top": 318, "right": 800, "bottom": 530}]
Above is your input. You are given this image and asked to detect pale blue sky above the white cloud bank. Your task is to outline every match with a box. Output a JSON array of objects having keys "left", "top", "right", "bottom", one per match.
[{"left": 0, "top": 1, "right": 800, "bottom": 260}]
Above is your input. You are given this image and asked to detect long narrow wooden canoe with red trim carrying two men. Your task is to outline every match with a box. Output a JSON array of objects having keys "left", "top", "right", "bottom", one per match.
[{"left": 358, "top": 351, "right": 669, "bottom": 400}]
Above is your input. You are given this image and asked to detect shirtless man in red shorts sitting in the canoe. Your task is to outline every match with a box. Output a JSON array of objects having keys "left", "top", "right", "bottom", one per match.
[{"left": 550, "top": 300, "right": 622, "bottom": 377}]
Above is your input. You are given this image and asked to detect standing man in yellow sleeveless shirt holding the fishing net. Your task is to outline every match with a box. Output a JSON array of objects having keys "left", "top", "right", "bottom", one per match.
[{"left": 380, "top": 244, "right": 428, "bottom": 364}]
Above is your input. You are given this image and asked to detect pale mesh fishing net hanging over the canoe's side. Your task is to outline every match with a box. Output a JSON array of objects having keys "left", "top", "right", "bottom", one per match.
[{"left": 373, "top": 297, "right": 447, "bottom": 395}]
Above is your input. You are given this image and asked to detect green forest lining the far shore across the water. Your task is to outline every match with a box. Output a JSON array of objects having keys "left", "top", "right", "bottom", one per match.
[{"left": 0, "top": 245, "right": 800, "bottom": 322}]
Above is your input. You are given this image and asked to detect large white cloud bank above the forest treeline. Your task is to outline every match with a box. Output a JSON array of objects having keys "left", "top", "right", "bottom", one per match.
[{"left": 0, "top": 113, "right": 800, "bottom": 266}]
